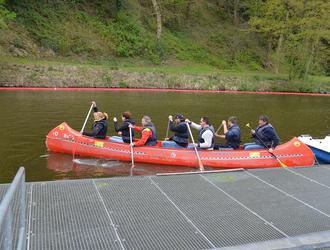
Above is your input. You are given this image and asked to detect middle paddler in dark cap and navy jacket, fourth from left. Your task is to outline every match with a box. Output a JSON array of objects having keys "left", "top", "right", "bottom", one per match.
[{"left": 162, "top": 114, "right": 189, "bottom": 148}]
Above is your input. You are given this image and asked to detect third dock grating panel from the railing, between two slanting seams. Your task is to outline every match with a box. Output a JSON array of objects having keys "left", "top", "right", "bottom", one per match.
[{"left": 152, "top": 175, "right": 284, "bottom": 247}]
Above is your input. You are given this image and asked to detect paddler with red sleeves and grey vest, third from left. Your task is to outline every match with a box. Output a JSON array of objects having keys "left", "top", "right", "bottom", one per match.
[{"left": 129, "top": 115, "right": 157, "bottom": 147}]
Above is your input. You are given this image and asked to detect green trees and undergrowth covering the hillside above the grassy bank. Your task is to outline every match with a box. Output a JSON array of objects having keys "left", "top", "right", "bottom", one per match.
[{"left": 0, "top": 0, "right": 330, "bottom": 79}]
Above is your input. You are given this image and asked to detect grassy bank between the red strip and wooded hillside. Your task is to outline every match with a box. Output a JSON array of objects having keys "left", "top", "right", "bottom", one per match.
[{"left": 0, "top": 57, "right": 330, "bottom": 93}]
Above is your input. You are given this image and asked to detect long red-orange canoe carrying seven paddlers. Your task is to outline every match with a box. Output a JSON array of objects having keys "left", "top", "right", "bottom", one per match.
[{"left": 46, "top": 122, "right": 314, "bottom": 168}]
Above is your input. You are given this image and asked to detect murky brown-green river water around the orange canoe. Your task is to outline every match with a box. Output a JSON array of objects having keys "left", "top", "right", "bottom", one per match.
[{"left": 0, "top": 90, "right": 330, "bottom": 183}]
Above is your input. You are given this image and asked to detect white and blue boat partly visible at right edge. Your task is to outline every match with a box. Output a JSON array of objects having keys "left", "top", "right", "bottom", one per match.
[{"left": 298, "top": 135, "right": 330, "bottom": 164}]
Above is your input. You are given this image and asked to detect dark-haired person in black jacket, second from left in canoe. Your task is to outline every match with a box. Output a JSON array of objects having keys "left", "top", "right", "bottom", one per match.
[{"left": 110, "top": 111, "right": 135, "bottom": 143}]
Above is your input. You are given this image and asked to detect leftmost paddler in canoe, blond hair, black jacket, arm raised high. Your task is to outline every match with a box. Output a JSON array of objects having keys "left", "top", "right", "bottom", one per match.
[{"left": 83, "top": 101, "right": 108, "bottom": 139}]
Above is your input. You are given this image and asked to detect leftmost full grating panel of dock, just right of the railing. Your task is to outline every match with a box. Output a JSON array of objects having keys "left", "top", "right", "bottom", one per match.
[{"left": 28, "top": 180, "right": 120, "bottom": 249}]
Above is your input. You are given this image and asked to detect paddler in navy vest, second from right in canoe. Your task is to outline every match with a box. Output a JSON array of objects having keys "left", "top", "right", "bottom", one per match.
[{"left": 214, "top": 116, "right": 241, "bottom": 149}]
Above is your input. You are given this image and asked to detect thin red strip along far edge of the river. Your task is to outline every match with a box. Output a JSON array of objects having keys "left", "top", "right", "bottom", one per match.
[{"left": 0, "top": 87, "right": 330, "bottom": 96}]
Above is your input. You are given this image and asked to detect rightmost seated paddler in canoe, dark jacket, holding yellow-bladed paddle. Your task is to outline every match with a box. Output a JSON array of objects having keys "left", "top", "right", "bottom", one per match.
[{"left": 244, "top": 115, "right": 280, "bottom": 151}]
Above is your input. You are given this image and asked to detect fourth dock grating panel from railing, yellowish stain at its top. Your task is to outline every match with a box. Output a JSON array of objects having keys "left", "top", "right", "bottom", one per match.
[{"left": 205, "top": 171, "right": 330, "bottom": 236}]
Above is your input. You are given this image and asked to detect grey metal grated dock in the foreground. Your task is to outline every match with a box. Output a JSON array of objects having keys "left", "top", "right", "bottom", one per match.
[{"left": 0, "top": 165, "right": 330, "bottom": 250}]
